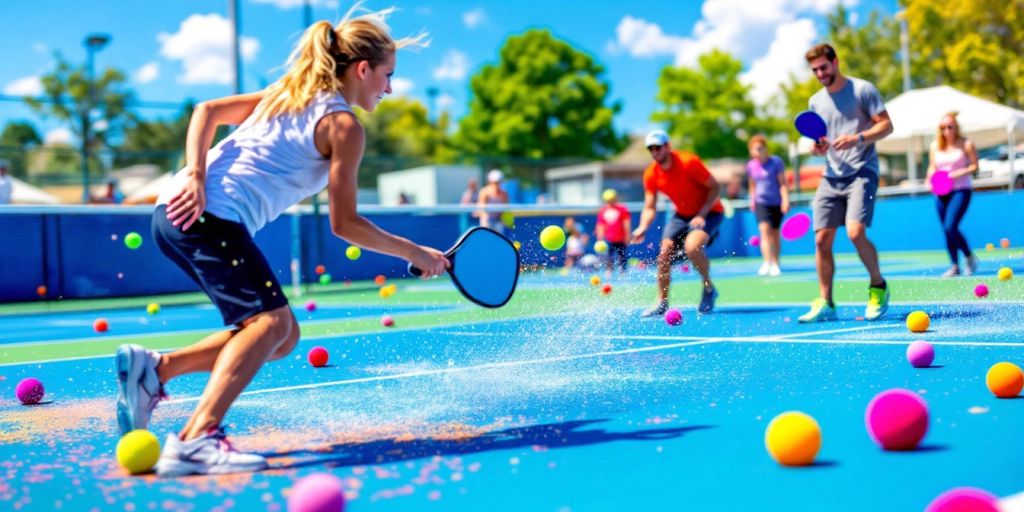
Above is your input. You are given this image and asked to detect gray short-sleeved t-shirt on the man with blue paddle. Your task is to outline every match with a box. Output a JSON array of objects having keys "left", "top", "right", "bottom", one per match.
[{"left": 807, "top": 77, "right": 886, "bottom": 178}]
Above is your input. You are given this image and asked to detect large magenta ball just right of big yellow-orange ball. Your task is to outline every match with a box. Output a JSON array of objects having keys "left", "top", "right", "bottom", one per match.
[{"left": 864, "top": 389, "right": 928, "bottom": 451}]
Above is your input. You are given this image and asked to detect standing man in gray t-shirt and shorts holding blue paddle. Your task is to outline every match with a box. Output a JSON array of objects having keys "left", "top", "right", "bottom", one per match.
[{"left": 800, "top": 44, "right": 893, "bottom": 323}]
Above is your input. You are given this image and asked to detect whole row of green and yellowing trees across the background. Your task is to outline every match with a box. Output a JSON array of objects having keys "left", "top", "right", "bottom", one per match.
[{"left": 0, "top": 0, "right": 1024, "bottom": 184}]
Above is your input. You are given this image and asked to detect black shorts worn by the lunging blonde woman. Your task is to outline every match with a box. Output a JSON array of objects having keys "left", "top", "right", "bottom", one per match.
[{"left": 153, "top": 205, "right": 288, "bottom": 326}]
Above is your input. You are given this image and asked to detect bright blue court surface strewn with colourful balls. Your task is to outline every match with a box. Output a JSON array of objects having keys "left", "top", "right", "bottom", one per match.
[{"left": 0, "top": 256, "right": 1024, "bottom": 512}]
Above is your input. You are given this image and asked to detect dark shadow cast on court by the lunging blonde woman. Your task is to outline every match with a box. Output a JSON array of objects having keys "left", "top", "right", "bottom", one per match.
[{"left": 263, "top": 420, "right": 714, "bottom": 469}]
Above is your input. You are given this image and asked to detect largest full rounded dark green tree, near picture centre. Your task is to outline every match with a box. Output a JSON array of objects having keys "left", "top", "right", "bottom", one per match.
[{"left": 456, "top": 30, "right": 626, "bottom": 159}]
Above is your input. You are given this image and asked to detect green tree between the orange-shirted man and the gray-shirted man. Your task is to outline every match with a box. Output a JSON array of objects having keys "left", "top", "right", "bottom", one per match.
[{"left": 651, "top": 49, "right": 774, "bottom": 158}]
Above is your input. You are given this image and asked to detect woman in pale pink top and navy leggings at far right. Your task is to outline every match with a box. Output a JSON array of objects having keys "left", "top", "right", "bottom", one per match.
[{"left": 925, "top": 113, "right": 978, "bottom": 278}]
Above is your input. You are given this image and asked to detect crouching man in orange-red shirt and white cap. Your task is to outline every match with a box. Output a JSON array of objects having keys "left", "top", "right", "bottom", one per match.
[{"left": 632, "top": 130, "right": 724, "bottom": 316}]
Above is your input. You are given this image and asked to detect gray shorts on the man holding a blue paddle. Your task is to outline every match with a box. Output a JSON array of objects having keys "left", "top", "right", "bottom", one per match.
[{"left": 812, "top": 169, "right": 879, "bottom": 231}]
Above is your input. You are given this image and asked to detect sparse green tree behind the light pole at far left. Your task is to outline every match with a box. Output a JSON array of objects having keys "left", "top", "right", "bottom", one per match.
[{"left": 26, "top": 53, "right": 133, "bottom": 175}]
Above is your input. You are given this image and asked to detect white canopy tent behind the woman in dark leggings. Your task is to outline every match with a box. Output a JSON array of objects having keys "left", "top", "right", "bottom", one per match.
[{"left": 876, "top": 85, "right": 1024, "bottom": 186}]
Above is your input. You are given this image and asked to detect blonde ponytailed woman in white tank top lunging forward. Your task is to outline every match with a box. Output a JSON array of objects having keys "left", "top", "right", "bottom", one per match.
[{"left": 117, "top": 8, "right": 449, "bottom": 476}]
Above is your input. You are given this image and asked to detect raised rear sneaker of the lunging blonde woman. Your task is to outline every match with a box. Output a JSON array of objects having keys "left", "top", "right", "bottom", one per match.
[{"left": 115, "top": 345, "right": 167, "bottom": 435}]
